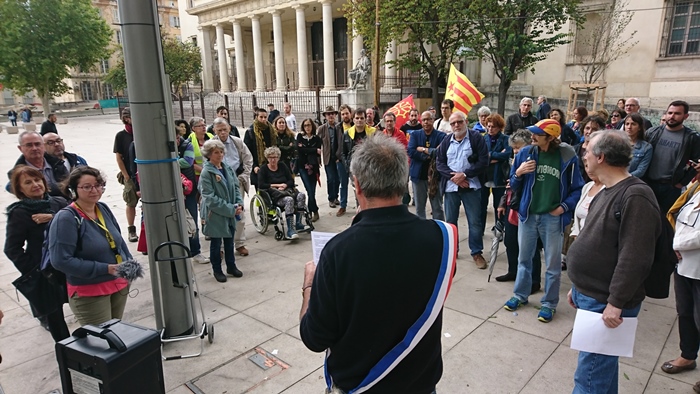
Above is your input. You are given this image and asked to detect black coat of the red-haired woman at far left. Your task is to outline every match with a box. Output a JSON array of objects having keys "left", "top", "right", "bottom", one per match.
[{"left": 5, "top": 197, "right": 68, "bottom": 275}]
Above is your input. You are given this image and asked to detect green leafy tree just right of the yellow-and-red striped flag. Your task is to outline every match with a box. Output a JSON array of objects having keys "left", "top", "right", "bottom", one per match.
[{"left": 463, "top": 0, "right": 582, "bottom": 114}]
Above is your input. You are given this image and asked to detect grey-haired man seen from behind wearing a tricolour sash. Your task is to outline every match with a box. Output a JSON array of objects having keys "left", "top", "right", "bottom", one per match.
[{"left": 299, "top": 134, "right": 457, "bottom": 394}]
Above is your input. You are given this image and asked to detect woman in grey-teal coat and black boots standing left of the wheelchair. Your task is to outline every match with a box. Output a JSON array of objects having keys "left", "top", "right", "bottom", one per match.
[{"left": 199, "top": 140, "right": 243, "bottom": 282}]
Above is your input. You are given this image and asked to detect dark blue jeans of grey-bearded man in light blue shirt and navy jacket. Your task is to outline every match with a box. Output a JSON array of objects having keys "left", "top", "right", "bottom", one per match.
[{"left": 445, "top": 190, "right": 484, "bottom": 256}]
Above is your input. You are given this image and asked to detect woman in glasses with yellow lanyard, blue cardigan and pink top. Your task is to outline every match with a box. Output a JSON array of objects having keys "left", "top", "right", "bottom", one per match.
[{"left": 49, "top": 166, "right": 132, "bottom": 326}]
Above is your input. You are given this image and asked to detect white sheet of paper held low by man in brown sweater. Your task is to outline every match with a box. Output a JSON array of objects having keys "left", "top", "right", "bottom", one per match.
[{"left": 571, "top": 309, "right": 638, "bottom": 357}]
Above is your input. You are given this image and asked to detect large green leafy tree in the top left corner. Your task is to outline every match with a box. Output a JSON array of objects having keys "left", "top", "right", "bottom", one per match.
[{"left": 0, "top": 0, "right": 112, "bottom": 114}]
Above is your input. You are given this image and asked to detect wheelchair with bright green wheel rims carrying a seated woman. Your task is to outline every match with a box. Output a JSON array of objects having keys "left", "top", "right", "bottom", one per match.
[{"left": 248, "top": 190, "right": 314, "bottom": 241}]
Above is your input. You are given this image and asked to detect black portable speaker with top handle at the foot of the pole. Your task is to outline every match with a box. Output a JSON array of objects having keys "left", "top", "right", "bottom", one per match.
[{"left": 56, "top": 319, "right": 165, "bottom": 394}]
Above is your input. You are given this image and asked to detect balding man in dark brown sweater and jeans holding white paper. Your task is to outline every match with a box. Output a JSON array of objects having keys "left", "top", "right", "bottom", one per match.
[{"left": 567, "top": 130, "right": 661, "bottom": 394}]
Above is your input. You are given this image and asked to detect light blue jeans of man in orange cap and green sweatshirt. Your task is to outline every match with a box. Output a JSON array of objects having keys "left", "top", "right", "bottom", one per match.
[{"left": 513, "top": 213, "right": 564, "bottom": 309}]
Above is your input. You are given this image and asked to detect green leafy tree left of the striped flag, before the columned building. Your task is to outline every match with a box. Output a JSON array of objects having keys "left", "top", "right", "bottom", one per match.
[{"left": 344, "top": 0, "right": 469, "bottom": 105}]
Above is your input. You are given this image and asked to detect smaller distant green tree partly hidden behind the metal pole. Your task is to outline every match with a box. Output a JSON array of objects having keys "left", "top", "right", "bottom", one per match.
[{"left": 103, "top": 36, "right": 202, "bottom": 94}]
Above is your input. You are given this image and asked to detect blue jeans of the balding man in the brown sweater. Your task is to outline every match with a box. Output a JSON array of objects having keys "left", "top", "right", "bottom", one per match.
[{"left": 571, "top": 286, "right": 642, "bottom": 394}]
